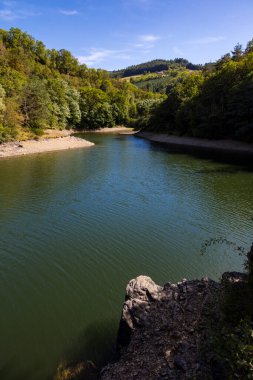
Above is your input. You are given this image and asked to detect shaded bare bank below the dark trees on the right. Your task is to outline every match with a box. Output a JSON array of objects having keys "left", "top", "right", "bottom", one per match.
[{"left": 135, "top": 132, "right": 253, "bottom": 160}]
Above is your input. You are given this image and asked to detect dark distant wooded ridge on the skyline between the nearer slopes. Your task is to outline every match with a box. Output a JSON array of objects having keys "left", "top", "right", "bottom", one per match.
[{"left": 110, "top": 58, "right": 202, "bottom": 78}]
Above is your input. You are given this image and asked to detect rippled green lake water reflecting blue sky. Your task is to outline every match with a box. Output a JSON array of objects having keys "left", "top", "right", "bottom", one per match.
[{"left": 0, "top": 134, "right": 253, "bottom": 380}]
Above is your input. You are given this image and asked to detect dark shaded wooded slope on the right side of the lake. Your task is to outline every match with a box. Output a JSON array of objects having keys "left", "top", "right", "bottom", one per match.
[{"left": 142, "top": 40, "right": 253, "bottom": 142}]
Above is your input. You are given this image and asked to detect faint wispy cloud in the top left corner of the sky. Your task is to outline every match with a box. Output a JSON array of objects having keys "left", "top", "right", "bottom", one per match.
[{"left": 0, "top": 0, "right": 40, "bottom": 21}]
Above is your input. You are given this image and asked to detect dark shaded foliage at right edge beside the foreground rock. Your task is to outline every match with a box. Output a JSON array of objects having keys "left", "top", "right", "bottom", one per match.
[{"left": 202, "top": 246, "right": 253, "bottom": 380}]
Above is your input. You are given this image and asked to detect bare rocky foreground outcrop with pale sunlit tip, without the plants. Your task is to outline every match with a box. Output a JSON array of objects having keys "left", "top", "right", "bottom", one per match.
[{"left": 99, "top": 273, "right": 245, "bottom": 380}]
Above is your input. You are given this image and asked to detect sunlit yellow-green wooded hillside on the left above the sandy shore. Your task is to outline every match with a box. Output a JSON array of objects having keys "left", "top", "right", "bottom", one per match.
[{"left": 0, "top": 28, "right": 159, "bottom": 142}]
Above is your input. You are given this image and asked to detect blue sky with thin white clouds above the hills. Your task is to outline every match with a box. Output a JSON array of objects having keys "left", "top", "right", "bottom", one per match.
[{"left": 0, "top": 0, "right": 253, "bottom": 70}]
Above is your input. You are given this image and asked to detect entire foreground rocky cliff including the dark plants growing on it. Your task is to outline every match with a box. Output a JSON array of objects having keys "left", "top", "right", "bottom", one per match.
[{"left": 54, "top": 270, "right": 253, "bottom": 380}]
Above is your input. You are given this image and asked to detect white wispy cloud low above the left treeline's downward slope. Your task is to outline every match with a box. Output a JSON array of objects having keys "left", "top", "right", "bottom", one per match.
[{"left": 77, "top": 49, "right": 131, "bottom": 66}]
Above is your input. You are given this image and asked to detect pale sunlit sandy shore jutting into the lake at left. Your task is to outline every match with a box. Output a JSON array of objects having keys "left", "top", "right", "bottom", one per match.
[{"left": 0, "top": 136, "right": 94, "bottom": 158}]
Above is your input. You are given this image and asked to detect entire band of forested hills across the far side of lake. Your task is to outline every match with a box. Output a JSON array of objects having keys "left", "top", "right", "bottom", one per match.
[{"left": 0, "top": 28, "right": 253, "bottom": 142}]
